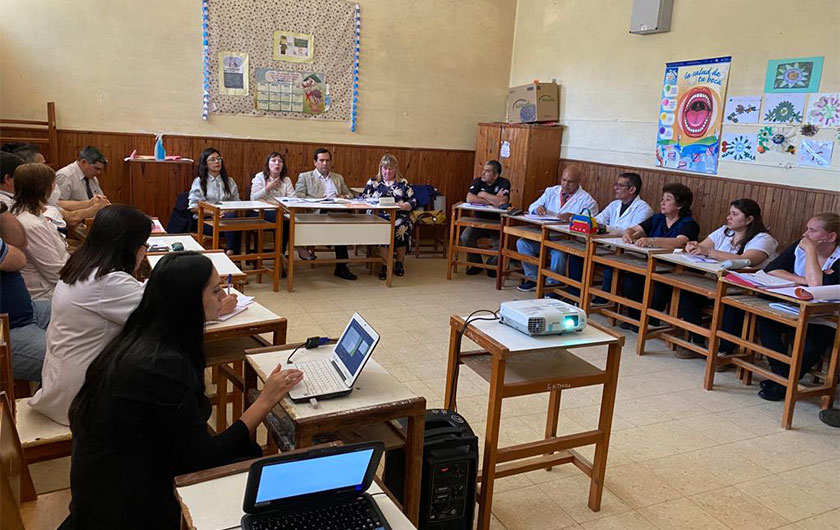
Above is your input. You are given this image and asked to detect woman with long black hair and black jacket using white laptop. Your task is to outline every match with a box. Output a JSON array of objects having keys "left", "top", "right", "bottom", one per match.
[{"left": 65, "top": 252, "right": 303, "bottom": 530}]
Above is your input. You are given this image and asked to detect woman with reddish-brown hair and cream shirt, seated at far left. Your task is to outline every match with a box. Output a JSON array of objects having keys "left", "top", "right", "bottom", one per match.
[{"left": 11, "top": 163, "right": 70, "bottom": 300}]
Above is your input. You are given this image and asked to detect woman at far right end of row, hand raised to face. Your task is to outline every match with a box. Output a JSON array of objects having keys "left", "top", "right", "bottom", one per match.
[{"left": 756, "top": 212, "right": 840, "bottom": 401}]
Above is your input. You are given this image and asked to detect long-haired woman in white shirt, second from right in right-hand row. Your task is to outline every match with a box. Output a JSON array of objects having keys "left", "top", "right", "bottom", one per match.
[{"left": 675, "top": 199, "right": 778, "bottom": 358}]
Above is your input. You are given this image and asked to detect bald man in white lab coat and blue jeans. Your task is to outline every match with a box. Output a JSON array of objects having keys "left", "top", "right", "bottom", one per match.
[{"left": 516, "top": 166, "right": 598, "bottom": 291}]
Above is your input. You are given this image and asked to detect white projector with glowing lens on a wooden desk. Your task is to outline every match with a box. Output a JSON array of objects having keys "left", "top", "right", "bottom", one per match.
[{"left": 499, "top": 298, "right": 586, "bottom": 335}]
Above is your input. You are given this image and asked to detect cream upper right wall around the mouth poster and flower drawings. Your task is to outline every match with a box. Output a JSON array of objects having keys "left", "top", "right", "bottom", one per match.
[{"left": 510, "top": 0, "right": 840, "bottom": 190}]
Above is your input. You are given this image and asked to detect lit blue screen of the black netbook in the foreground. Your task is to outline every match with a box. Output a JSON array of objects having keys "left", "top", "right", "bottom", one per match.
[{"left": 255, "top": 448, "right": 374, "bottom": 506}]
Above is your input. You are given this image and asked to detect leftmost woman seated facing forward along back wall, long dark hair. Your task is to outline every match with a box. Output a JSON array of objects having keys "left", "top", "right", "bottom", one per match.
[{"left": 187, "top": 147, "right": 242, "bottom": 254}]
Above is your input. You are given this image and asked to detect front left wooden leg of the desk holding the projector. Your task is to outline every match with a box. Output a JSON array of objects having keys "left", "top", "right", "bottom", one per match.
[{"left": 476, "top": 355, "right": 507, "bottom": 530}]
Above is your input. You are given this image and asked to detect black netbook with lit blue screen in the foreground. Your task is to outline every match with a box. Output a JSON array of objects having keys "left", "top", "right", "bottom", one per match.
[{"left": 242, "top": 442, "right": 391, "bottom": 530}]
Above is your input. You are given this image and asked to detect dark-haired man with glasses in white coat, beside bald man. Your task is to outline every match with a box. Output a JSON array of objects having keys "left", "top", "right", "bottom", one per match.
[{"left": 569, "top": 173, "right": 653, "bottom": 303}]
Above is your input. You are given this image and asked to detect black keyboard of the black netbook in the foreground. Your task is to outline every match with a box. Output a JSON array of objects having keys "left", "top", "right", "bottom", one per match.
[{"left": 244, "top": 497, "right": 386, "bottom": 530}]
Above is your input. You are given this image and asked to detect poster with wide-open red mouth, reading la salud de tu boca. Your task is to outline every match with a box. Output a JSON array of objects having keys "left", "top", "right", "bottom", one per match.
[{"left": 656, "top": 57, "right": 732, "bottom": 175}]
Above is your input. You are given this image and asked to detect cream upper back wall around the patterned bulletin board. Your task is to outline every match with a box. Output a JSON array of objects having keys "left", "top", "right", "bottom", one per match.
[{"left": 0, "top": 0, "right": 516, "bottom": 149}]
